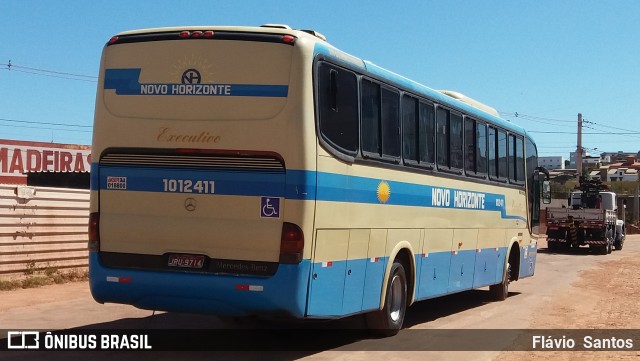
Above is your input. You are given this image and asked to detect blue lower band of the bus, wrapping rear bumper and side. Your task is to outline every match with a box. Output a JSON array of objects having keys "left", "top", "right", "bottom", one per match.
[{"left": 89, "top": 246, "right": 536, "bottom": 318}]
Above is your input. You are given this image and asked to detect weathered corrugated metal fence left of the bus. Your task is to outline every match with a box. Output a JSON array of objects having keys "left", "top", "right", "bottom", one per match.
[{"left": 0, "top": 185, "right": 89, "bottom": 278}]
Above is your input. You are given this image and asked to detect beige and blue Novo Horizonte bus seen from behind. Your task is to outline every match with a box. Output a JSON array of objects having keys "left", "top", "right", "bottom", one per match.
[{"left": 89, "top": 24, "right": 542, "bottom": 335}]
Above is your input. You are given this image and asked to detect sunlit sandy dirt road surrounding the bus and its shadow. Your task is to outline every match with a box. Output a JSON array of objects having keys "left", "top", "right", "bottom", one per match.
[{"left": 0, "top": 236, "right": 640, "bottom": 361}]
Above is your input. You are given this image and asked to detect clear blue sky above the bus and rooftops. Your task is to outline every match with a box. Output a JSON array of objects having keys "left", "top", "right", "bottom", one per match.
[{"left": 0, "top": 0, "right": 640, "bottom": 159}]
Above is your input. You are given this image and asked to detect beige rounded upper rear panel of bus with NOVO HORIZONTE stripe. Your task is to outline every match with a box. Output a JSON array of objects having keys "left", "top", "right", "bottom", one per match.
[{"left": 103, "top": 41, "right": 293, "bottom": 120}]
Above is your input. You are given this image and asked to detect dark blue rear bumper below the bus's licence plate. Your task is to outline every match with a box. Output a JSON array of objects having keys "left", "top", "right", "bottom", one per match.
[{"left": 89, "top": 252, "right": 310, "bottom": 318}]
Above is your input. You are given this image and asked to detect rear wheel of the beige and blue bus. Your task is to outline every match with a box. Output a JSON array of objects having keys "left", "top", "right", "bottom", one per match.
[{"left": 365, "top": 262, "right": 407, "bottom": 336}]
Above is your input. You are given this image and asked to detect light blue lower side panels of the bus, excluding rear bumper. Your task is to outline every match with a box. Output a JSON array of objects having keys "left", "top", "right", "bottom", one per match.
[{"left": 307, "top": 247, "right": 507, "bottom": 317}]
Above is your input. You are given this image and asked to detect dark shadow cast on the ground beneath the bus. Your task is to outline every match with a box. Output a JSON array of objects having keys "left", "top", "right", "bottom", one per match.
[{"left": 9, "top": 290, "right": 519, "bottom": 361}]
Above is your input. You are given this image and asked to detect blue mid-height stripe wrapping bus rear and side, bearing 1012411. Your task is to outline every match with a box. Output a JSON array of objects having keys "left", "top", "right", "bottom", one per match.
[{"left": 91, "top": 165, "right": 526, "bottom": 222}]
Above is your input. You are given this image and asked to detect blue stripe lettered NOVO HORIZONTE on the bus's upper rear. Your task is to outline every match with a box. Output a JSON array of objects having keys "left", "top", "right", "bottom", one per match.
[{"left": 104, "top": 68, "right": 289, "bottom": 98}]
